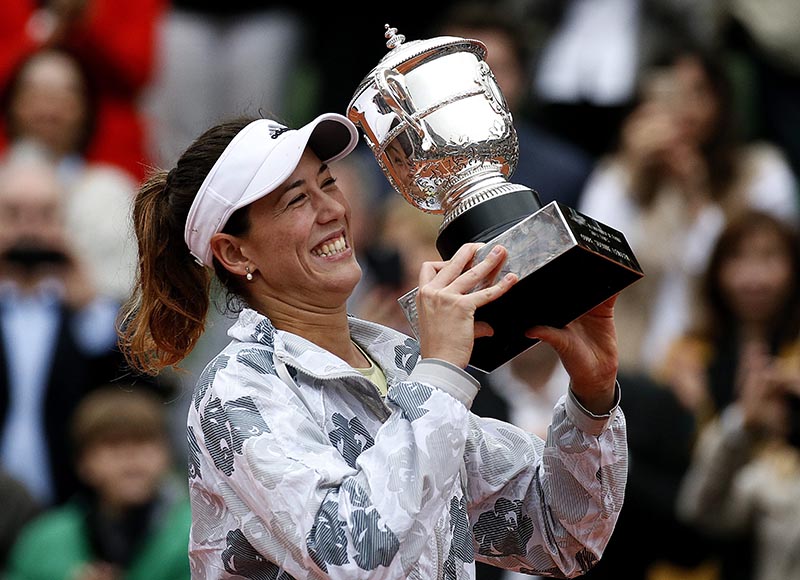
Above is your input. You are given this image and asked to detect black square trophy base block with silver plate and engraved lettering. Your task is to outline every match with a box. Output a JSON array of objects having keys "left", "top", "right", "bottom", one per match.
[{"left": 398, "top": 201, "right": 643, "bottom": 373}]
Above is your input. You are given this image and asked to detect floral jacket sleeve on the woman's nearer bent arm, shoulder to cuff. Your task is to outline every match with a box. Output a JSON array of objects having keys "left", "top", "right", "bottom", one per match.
[{"left": 189, "top": 360, "right": 477, "bottom": 579}]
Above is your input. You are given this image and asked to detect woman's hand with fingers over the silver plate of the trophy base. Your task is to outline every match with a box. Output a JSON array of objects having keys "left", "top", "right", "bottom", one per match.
[{"left": 416, "top": 243, "right": 518, "bottom": 368}]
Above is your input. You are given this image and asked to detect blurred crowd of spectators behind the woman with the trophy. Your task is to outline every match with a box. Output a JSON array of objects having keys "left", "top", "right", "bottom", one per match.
[{"left": 0, "top": 0, "right": 800, "bottom": 580}]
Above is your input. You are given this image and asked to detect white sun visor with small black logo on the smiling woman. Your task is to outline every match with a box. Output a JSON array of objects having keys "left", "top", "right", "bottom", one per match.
[{"left": 184, "top": 113, "right": 358, "bottom": 266}]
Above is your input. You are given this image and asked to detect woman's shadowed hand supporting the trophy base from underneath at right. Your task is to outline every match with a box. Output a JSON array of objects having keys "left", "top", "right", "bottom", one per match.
[{"left": 525, "top": 295, "right": 619, "bottom": 415}]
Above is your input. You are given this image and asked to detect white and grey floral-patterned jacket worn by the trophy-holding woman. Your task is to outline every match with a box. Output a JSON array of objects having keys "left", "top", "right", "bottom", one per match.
[{"left": 188, "top": 310, "right": 627, "bottom": 580}]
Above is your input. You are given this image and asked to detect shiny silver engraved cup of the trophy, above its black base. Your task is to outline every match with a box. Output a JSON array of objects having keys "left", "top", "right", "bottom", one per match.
[{"left": 347, "top": 24, "right": 528, "bottom": 231}]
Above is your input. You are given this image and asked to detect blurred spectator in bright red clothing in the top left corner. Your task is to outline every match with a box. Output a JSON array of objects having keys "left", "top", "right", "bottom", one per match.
[{"left": 0, "top": 0, "right": 165, "bottom": 182}]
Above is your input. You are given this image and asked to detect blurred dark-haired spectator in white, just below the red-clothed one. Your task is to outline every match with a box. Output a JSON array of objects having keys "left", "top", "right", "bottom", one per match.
[{"left": 2, "top": 48, "right": 136, "bottom": 302}]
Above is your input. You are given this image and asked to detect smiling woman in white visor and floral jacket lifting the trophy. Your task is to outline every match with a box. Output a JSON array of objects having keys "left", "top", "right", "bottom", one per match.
[{"left": 121, "top": 114, "right": 627, "bottom": 579}]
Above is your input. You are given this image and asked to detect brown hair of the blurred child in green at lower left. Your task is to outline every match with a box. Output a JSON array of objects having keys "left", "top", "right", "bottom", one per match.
[{"left": 70, "top": 385, "right": 169, "bottom": 456}]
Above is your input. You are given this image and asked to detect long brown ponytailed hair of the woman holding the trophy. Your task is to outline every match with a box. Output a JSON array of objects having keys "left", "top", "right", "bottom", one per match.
[{"left": 118, "top": 118, "right": 254, "bottom": 375}]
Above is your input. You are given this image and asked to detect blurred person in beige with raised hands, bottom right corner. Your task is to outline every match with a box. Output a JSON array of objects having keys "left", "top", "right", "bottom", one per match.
[{"left": 679, "top": 349, "right": 800, "bottom": 580}]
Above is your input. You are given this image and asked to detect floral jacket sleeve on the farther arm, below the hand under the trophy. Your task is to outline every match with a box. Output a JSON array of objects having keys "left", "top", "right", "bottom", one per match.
[{"left": 465, "top": 386, "right": 627, "bottom": 578}]
